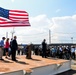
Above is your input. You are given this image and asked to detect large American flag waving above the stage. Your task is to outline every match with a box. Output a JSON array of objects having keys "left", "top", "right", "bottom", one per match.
[{"left": 0, "top": 7, "right": 30, "bottom": 27}]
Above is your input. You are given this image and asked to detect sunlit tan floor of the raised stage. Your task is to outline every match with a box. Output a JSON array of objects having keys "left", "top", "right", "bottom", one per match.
[{"left": 0, "top": 55, "right": 67, "bottom": 73}]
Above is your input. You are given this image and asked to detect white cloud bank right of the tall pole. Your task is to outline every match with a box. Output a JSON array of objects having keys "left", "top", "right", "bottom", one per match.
[{"left": 52, "top": 15, "right": 76, "bottom": 43}]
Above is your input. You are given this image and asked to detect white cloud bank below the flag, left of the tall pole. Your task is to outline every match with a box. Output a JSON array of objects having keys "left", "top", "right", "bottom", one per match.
[{"left": 0, "top": 15, "right": 51, "bottom": 43}]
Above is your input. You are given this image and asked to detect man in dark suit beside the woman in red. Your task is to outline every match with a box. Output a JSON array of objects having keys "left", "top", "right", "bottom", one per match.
[{"left": 11, "top": 36, "right": 18, "bottom": 61}]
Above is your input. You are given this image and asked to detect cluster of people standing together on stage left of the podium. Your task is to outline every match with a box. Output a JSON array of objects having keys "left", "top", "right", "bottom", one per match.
[{"left": 0, "top": 36, "right": 18, "bottom": 61}]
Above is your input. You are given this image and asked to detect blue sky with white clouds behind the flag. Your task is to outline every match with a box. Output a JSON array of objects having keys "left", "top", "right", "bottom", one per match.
[{"left": 0, "top": 0, "right": 76, "bottom": 44}]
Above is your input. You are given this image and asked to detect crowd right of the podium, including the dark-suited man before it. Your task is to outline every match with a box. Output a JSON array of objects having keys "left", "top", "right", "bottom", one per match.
[{"left": 33, "top": 39, "right": 76, "bottom": 60}]
